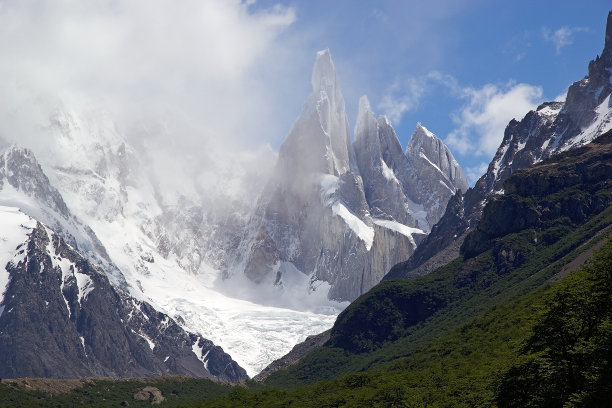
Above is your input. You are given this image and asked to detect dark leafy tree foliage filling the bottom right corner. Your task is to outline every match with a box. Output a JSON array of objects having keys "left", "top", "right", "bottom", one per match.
[{"left": 497, "top": 239, "right": 612, "bottom": 407}]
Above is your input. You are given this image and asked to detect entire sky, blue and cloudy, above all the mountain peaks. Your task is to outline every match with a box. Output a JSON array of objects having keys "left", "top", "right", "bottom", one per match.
[{"left": 0, "top": 0, "right": 612, "bottom": 184}]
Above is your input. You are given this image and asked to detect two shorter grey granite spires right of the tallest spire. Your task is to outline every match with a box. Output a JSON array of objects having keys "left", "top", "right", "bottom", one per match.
[{"left": 353, "top": 96, "right": 468, "bottom": 232}]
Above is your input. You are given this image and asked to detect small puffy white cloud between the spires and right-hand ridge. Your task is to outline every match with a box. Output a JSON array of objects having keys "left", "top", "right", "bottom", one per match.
[{"left": 445, "top": 83, "right": 542, "bottom": 157}]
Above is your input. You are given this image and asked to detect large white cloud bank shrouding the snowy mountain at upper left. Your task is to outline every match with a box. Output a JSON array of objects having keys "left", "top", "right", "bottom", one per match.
[{"left": 0, "top": 0, "right": 298, "bottom": 207}]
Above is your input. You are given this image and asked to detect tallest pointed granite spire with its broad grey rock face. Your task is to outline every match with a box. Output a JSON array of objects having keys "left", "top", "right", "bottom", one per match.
[{"left": 233, "top": 51, "right": 414, "bottom": 300}]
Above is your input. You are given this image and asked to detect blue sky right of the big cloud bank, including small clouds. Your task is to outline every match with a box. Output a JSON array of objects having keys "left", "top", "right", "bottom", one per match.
[{"left": 251, "top": 0, "right": 612, "bottom": 183}]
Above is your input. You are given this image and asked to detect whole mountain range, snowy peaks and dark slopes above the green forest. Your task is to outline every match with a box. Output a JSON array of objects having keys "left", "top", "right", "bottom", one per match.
[{"left": 0, "top": 8, "right": 612, "bottom": 396}]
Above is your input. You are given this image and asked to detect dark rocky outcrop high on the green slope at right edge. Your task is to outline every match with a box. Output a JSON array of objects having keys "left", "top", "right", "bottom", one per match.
[{"left": 461, "top": 130, "right": 612, "bottom": 258}]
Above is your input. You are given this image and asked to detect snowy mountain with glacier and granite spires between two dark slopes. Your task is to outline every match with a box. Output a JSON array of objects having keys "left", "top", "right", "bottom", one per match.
[{"left": 0, "top": 52, "right": 464, "bottom": 376}]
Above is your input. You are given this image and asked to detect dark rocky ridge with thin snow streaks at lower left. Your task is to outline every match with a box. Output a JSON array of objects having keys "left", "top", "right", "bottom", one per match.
[{"left": 0, "top": 214, "right": 247, "bottom": 381}]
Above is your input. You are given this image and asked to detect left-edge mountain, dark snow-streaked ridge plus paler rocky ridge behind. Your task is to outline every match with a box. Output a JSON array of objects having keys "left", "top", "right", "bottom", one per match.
[{"left": 0, "top": 147, "right": 248, "bottom": 381}]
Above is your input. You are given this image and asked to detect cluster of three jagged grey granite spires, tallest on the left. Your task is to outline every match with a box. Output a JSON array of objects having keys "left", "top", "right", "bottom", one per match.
[{"left": 229, "top": 50, "right": 467, "bottom": 301}]
